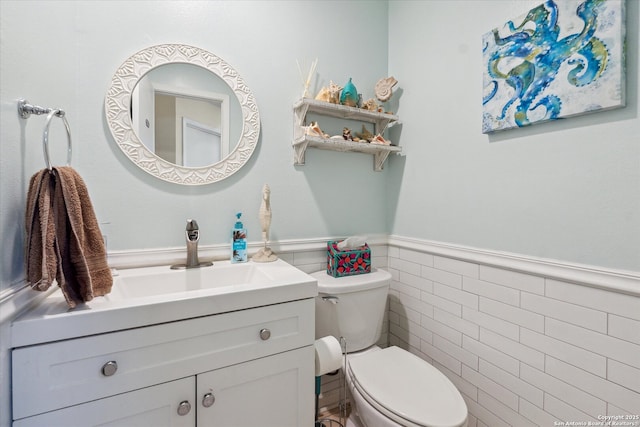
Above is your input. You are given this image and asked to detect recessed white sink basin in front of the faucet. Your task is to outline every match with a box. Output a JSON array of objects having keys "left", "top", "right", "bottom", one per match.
[{"left": 113, "top": 262, "right": 276, "bottom": 298}]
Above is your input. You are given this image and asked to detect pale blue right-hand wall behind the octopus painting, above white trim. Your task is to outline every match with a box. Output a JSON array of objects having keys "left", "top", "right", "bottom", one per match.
[{"left": 387, "top": 0, "right": 640, "bottom": 271}]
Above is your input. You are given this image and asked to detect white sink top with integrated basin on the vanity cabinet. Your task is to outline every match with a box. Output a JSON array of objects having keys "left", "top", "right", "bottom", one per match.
[{"left": 11, "top": 259, "right": 318, "bottom": 347}]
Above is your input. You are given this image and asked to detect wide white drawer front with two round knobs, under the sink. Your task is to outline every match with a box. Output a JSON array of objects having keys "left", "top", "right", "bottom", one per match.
[{"left": 12, "top": 298, "right": 315, "bottom": 419}]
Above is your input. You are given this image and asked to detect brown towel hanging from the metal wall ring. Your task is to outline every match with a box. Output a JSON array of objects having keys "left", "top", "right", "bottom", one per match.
[{"left": 26, "top": 166, "right": 113, "bottom": 308}]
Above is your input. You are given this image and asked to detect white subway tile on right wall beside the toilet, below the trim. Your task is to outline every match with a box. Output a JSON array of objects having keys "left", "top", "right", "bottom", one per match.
[{"left": 388, "top": 242, "right": 640, "bottom": 427}]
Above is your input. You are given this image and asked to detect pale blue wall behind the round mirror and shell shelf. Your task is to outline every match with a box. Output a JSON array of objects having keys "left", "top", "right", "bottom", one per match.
[{"left": 0, "top": 0, "right": 388, "bottom": 287}]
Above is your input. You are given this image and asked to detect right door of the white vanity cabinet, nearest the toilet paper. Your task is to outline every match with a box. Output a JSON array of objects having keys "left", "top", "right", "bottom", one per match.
[{"left": 196, "top": 346, "right": 315, "bottom": 427}]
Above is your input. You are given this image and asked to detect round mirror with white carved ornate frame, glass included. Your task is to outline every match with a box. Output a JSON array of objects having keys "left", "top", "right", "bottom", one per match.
[{"left": 105, "top": 44, "right": 260, "bottom": 185}]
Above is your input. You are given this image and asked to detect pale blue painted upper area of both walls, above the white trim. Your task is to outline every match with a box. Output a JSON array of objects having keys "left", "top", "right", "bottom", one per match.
[{"left": 0, "top": 0, "right": 640, "bottom": 298}]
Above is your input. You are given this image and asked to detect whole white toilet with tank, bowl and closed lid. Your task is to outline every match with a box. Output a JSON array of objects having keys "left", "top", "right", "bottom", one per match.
[{"left": 312, "top": 269, "right": 467, "bottom": 427}]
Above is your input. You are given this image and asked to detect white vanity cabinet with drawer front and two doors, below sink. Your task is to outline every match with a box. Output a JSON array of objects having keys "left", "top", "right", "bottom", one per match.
[{"left": 12, "top": 298, "right": 315, "bottom": 427}]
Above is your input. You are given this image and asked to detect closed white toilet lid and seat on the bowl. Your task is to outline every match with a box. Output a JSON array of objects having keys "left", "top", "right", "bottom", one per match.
[{"left": 348, "top": 347, "right": 467, "bottom": 427}]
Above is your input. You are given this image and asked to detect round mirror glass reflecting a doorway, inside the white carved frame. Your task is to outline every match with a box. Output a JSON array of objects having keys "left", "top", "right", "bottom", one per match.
[{"left": 131, "top": 64, "right": 242, "bottom": 167}]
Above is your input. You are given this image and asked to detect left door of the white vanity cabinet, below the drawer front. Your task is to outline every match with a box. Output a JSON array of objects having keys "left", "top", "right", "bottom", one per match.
[{"left": 13, "top": 377, "right": 196, "bottom": 427}]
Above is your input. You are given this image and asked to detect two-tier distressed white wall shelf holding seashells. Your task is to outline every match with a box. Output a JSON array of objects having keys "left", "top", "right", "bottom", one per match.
[{"left": 293, "top": 98, "right": 402, "bottom": 171}]
